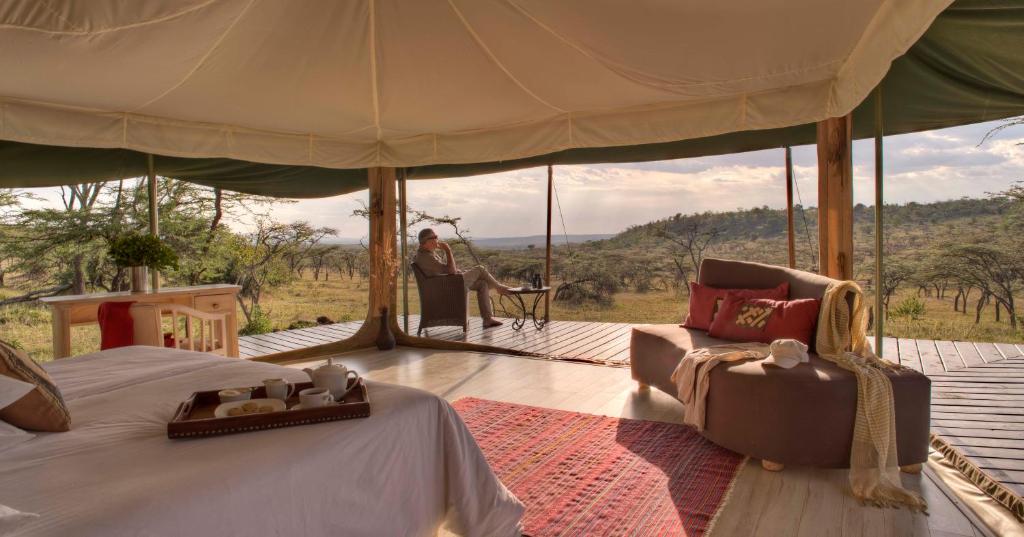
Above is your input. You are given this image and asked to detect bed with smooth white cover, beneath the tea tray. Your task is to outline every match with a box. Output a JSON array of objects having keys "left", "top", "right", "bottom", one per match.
[{"left": 0, "top": 346, "right": 522, "bottom": 537}]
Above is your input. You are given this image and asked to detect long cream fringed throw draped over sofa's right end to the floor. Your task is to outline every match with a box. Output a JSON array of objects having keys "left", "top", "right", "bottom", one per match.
[{"left": 815, "top": 281, "right": 928, "bottom": 511}]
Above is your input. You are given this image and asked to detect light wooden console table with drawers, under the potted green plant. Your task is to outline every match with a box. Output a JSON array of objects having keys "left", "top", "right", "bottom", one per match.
[{"left": 39, "top": 284, "right": 242, "bottom": 359}]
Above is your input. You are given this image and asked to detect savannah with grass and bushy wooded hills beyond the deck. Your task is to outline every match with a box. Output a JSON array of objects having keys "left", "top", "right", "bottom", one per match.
[{"left": 0, "top": 192, "right": 1024, "bottom": 361}]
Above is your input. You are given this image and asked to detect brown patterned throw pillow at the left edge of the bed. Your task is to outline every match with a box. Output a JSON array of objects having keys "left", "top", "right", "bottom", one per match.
[{"left": 0, "top": 341, "right": 71, "bottom": 432}]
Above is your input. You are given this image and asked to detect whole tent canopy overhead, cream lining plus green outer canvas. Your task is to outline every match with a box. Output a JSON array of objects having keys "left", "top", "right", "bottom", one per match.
[{"left": 0, "top": 0, "right": 1024, "bottom": 197}]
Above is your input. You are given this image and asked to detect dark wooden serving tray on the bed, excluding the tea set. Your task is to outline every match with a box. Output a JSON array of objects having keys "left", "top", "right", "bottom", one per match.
[{"left": 167, "top": 378, "right": 370, "bottom": 439}]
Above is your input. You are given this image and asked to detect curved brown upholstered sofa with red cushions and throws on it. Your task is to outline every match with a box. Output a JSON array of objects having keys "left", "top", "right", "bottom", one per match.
[{"left": 630, "top": 258, "right": 931, "bottom": 468}]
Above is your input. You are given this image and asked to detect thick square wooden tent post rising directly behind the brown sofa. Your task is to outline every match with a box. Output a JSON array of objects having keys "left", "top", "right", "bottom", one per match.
[{"left": 817, "top": 114, "right": 853, "bottom": 280}]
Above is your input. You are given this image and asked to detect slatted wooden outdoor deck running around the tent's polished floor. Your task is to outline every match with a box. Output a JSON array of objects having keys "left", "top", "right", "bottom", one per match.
[{"left": 245, "top": 316, "right": 1024, "bottom": 504}]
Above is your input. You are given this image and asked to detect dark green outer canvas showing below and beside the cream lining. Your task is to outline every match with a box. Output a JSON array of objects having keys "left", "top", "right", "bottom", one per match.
[{"left": 0, "top": 0, "right": 1024, "bottom": 198}]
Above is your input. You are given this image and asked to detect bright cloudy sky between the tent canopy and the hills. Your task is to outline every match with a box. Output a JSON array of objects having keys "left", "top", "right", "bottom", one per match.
[{"left": 16, "top": 122, "right": 1024, "bottom": 240}]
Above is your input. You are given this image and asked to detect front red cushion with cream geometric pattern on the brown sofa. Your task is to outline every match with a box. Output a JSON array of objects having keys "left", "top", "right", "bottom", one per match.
[{"left": 708, "top": 293, "right": 820, "bottom": 345}]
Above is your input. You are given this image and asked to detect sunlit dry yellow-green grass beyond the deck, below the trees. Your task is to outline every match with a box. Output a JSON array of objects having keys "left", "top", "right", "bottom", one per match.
[{"left": 6, "top": 275, "right": 1024, "bottom": 361}]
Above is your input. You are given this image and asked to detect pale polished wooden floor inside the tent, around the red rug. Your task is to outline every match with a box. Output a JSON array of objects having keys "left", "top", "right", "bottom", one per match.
[{"left": 293, "top": 347, "right": 990, "bottom": 537}]
